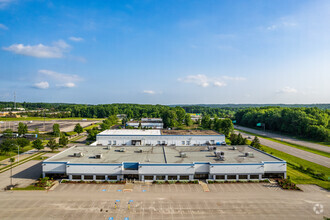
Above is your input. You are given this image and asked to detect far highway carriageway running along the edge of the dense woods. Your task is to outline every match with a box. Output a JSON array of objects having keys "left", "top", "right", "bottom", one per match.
[{"left": 235, "top": 125, "right": 330, "bottom": 153}]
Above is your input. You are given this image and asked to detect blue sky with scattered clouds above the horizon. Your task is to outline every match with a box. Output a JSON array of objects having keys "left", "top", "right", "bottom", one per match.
[{"left": 0, "top": 0, "right": 330, "bottom": 104}]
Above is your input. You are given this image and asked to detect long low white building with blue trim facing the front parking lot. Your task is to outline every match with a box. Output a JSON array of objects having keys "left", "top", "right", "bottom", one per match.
[{"left": 42, "top": 146, "right": 286, "bottom": 181}]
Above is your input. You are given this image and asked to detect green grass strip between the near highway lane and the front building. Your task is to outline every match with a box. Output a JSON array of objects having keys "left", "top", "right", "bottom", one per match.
[{"left": 248, "top": 141, "right": 330, "bottom": 190}]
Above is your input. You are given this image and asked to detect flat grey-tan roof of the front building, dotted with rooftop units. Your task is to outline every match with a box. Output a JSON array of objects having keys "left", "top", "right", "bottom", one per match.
[{"left": 46, "top": 146, "right": 281, "bottom": 164}]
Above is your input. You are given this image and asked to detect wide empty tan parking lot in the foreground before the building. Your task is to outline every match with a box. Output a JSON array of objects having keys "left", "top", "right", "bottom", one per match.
[{"left": 0, "top": 183, "right": 330, "bottom": 220}]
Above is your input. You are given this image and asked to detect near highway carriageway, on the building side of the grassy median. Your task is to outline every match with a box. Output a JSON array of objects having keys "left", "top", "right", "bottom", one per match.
[{"left": 235, "top": 131, "right": 330, "bottom": 168}]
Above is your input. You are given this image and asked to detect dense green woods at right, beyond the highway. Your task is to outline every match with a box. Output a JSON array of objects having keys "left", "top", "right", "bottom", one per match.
[{"left": 235, "top": 107, "right": 330, "bottom": 141}]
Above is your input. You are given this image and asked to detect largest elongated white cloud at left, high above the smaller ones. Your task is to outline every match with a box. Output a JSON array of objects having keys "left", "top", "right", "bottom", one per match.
[{"left": 3, "top": 40, "right": 70, "bottom": 58}]
